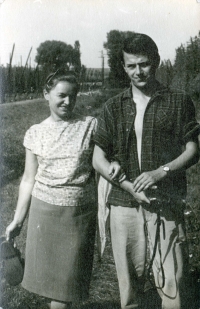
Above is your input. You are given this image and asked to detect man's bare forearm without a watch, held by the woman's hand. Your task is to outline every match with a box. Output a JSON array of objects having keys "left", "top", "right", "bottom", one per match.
[{"left": 93, "top": 145, "right": 150, "bottom": 204}]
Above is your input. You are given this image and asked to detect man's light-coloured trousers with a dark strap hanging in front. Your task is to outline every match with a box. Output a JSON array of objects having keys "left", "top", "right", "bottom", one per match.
[{"left": 110, "top": 206, "right": 187, "bottom": 309}]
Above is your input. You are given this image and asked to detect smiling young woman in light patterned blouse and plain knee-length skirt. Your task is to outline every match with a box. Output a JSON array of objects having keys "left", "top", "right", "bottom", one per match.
[{"left": 6, "top": 70, "right": 97, "bottom": 309}]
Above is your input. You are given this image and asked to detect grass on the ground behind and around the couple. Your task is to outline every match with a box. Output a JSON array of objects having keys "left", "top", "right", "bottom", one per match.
[{"left": 0, "top": 91, "right": 200, "bottom": 309}]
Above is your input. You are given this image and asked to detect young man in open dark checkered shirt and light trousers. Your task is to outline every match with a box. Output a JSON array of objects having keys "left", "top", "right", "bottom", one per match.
[{"left": 93, "top": 33, "right": 199, "bottom": 309}]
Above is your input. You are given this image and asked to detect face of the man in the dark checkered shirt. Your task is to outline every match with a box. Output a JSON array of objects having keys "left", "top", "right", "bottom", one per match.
[{"left": 123, "top": 52, "right": 154, "bottom": 88}]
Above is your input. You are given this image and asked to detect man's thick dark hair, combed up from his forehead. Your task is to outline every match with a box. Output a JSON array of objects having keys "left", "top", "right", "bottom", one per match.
[{"left": 121, "top": 33, "right": 160, "bottom": 70}]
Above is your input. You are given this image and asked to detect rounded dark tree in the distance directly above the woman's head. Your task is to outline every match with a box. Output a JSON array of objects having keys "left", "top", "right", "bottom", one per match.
[{"left": 35, "top": 40, "right": 80, "bottom": 71}]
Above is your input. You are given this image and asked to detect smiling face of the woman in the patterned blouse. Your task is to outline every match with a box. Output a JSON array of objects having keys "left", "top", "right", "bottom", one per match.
[{"left": 44, "top": 81, "right": 77, "bottom": 121}]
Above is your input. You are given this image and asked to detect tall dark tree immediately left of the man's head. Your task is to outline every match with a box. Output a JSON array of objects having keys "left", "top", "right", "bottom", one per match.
[{"left": 104, "top": 30, "right": 134, "bottom": 87}]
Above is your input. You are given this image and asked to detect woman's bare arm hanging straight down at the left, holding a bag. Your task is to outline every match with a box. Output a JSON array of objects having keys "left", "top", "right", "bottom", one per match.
[{"left": 6, "top": 149, "right": 38, "bottom": 240}]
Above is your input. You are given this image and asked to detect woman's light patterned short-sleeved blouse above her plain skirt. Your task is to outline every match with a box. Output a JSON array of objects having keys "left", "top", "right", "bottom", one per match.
[{"left": 24, "top": 116, "right": 97, "bottom": 206}]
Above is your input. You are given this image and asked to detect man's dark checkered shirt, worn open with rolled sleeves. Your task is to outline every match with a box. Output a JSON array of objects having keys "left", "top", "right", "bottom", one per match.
[{"left": 94, "top": 83, "right": 200, "bottom": 207}]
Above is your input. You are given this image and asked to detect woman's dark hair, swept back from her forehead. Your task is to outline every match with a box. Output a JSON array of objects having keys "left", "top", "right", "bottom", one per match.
[{"left": 44, "top": 69, "right": 80, "bottom": 93}]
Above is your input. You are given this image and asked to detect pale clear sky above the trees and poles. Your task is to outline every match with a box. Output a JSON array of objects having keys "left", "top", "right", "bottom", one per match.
[{"left": 0, "top": 0, "right": 200, "bottom": 68}]
